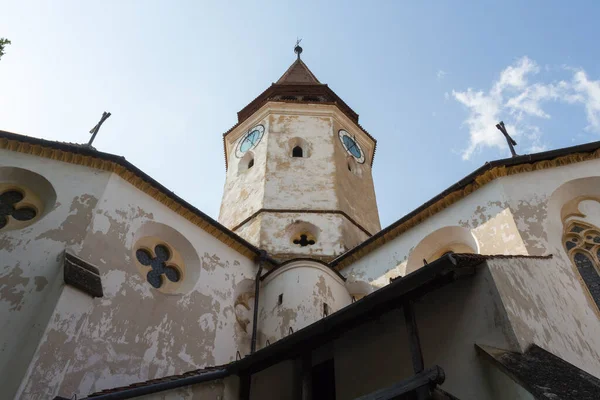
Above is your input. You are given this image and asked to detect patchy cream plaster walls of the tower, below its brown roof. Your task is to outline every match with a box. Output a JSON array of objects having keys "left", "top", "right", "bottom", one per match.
[{"left": 219, "top": 102, "right": 380, "bottom": 259}]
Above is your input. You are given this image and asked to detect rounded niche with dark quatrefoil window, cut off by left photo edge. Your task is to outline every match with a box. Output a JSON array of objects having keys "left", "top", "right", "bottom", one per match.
[{"left": 0, "top": 167, "right": 56, "bottom": 231}]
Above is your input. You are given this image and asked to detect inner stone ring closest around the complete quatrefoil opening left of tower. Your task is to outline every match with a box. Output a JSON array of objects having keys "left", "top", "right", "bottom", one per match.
[{"left": 133, "top": 236, "right": 186, "bottom": 294}]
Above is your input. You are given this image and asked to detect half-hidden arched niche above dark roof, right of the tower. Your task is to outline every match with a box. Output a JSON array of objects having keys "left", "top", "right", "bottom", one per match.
[{"left": 406, "top": 226, "right": 479, "bottom": 274}]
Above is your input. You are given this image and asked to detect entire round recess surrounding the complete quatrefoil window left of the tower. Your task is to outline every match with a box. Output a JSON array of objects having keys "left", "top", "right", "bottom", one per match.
[{"left": 131, "top": 221, "right": 201, "bottom": 294}]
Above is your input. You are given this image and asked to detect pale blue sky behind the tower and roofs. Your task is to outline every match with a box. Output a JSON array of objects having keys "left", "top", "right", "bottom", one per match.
[{"left": 0, "top": 1, "right": 600, "bottom": 226}]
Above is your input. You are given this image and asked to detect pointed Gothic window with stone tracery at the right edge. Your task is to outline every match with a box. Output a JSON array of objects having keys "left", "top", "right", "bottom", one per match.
[{"left": 563, "top": 217, "right": 600, "bottom": 308}]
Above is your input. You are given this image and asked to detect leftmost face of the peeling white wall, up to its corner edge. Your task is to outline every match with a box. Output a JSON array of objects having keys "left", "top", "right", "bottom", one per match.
[{"left": 0, "top": 150, "right": 110, "bottom": 398}]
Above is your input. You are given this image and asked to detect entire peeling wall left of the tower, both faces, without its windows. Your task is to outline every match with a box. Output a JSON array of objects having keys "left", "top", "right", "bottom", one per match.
[{"left": 0, "top": 153, "right": 255, "bottom": 399}]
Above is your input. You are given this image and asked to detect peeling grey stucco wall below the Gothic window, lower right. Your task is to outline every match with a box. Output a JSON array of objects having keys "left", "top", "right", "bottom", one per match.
[{"left": 488, "top": 255, "right": 600, "bottom": 376}]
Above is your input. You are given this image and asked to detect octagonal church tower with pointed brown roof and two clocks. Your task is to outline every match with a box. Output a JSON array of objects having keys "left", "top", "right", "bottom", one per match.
[{"left": 219, "top": 46, "right": 381, "bottom": 261}]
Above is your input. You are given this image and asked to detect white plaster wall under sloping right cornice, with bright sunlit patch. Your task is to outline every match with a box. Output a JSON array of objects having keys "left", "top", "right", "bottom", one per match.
[{"left": 342, "top": 160, "right": 600, "bottom": 286}]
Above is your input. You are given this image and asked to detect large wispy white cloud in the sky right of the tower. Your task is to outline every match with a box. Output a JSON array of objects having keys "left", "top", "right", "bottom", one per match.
[{"left": 452, "top": 57, "right": 600, "bottom": 160}]
